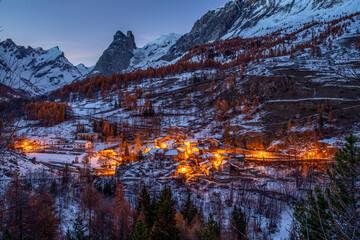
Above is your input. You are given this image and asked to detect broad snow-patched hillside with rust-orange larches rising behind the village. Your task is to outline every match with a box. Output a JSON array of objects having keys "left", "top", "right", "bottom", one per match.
[{"left": 48, "top": 11, "right": 360, "bottom": 158}]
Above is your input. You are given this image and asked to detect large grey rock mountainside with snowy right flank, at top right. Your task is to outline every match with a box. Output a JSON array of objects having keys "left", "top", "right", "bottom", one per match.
[{"left": 164, "top": 0, "right": 360, "bottom": 60}]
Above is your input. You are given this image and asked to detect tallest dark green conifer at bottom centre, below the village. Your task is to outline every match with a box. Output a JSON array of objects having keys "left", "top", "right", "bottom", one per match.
[{"left": 151, "top": 187, "right": 180, "bottom": 240}]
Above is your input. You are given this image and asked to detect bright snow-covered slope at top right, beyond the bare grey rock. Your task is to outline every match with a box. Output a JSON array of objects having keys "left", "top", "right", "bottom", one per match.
[{"left": 224, "top": 0, "right": 360, "bottom": 39}]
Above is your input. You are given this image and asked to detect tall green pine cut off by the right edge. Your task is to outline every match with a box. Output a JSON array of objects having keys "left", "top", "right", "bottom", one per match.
[{"left": 326, "top": 135, "right": 360, "bottom": 239}]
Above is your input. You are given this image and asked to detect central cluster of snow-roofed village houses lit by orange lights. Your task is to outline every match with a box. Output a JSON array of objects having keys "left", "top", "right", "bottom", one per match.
[{"left": 140, "top": 137, "right": 245, "bottom": 180}]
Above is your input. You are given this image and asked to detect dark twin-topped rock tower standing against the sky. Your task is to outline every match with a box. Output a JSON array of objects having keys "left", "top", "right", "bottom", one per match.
[{"left": 93, "top": 31, "right": 136, "bottom": 76}]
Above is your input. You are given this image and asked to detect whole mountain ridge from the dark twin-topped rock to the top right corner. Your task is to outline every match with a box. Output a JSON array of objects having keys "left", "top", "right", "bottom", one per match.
[{"left": 95, "top": 0, "right": 360, "bottom": 76}]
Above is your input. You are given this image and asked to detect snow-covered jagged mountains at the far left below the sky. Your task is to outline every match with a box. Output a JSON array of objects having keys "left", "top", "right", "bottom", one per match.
[{"left": 0, "top": 39, "right": 91, "bottom": 95}]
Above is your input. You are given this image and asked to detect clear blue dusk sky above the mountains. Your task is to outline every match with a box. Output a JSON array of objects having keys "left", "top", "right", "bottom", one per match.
[{"left": 0, "top": 0, "right": 229, "bottom": 66}]
